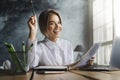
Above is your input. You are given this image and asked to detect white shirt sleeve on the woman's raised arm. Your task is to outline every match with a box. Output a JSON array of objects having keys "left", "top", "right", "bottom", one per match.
[{"left": 27, "top": 39, "right": 42, "bottom": 68}]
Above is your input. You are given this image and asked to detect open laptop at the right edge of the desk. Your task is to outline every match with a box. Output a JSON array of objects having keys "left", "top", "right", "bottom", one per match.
[{"left": 80, "top": 37, "right": 120, "bottom": 71}]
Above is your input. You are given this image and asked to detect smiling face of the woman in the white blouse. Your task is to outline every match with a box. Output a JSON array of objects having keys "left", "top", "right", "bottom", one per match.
[{"left": 46, "top": 14, "right": 62, "bottom": 41}]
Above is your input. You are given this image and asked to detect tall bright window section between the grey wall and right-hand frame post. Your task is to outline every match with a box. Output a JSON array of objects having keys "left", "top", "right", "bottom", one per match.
[{"left": 93, "top": 0, "right": 114, "bottom": 65}]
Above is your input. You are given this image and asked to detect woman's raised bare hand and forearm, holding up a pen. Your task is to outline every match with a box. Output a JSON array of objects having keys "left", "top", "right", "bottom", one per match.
[{"left": 28, "top": 16, "right": 38, "bottom": 41}]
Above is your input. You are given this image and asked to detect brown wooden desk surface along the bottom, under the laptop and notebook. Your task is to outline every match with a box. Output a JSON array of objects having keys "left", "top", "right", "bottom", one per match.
[{"left": 0, "top": 70, "right": 120, "bottom": 80}]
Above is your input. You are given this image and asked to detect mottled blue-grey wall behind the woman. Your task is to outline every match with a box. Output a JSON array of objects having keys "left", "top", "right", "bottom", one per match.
[{"left": 0, "top": 0, "right": 89, "bottom": 65}]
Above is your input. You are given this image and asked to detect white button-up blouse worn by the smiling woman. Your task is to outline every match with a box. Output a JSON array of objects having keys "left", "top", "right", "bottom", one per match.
[{"left": 27, "top": 38, "right": 73, "bottom": 68}]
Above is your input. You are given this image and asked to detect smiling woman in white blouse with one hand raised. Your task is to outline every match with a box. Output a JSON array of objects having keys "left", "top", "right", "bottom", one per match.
[{"left": 27, "top": 9, "right": 73, "bottom": 68}]
